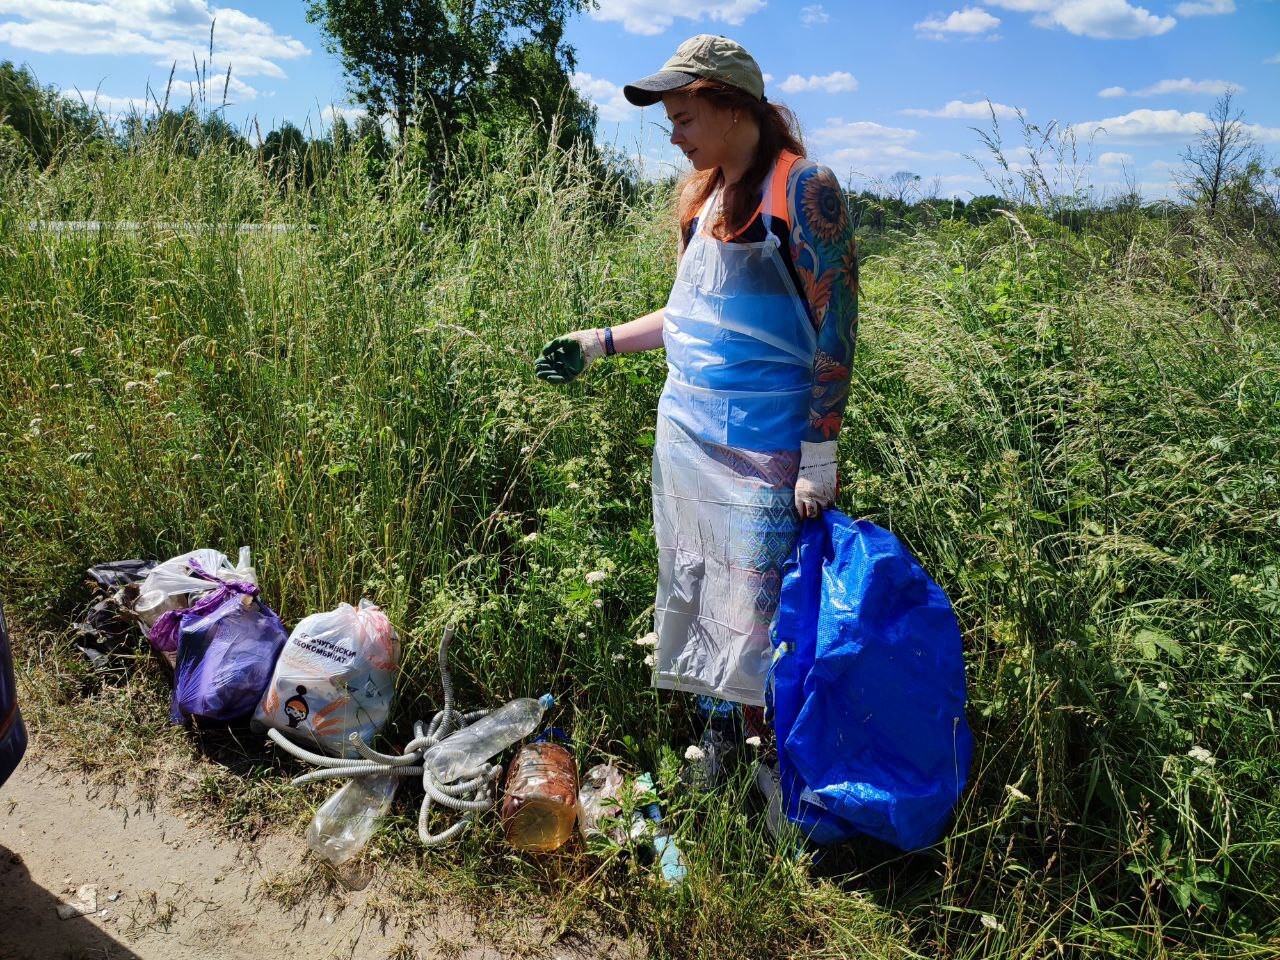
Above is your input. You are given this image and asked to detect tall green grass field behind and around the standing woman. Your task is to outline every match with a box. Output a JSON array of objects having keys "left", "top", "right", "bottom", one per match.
[{"left": 0, "top": 124, "right": 1280, "bottom": 957}]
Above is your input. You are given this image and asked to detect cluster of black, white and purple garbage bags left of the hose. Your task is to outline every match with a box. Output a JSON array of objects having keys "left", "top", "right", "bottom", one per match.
[{"left": 76, "top": 547, "right": 399, "bottom": 755}]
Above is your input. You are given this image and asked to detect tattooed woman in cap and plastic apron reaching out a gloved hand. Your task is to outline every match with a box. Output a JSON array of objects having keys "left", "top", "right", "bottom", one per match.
[{"left": 536, "top": 35, "right": 858, "bottom": 768}]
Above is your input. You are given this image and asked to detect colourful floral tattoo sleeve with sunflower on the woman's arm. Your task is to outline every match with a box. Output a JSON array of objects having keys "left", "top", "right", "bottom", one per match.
[{"left": 787, "top": 164, "right": 858, "bottom": 443}]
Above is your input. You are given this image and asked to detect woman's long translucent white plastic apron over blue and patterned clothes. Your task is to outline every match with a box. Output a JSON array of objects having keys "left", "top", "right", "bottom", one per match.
[{"left": 653, "top": 152, "right": 817, "bottom": 705}]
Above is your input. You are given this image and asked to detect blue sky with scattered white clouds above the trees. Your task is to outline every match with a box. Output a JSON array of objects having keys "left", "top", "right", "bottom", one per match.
[{"left": 0, "top": 0, "right": 1280, "bottom": 196}]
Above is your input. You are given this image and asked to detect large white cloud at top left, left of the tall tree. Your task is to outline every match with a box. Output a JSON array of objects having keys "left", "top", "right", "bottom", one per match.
[{"left": 0, "top": 0, "right": 304, "bottom": 78}]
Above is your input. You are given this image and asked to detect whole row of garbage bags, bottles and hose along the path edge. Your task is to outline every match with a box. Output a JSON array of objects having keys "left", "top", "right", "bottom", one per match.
[{"left": 76, "top": 547, "right": 685, "bottom": 883}]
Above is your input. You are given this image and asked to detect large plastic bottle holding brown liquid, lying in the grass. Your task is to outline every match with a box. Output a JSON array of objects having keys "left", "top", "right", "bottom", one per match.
[{"left": 502, "top": 741, "right": 577, "bottom": 852}]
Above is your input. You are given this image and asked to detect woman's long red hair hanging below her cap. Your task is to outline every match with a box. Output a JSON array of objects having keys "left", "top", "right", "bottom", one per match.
[{"left": 676, "top": 77, "right": 805, "bottom": 239}]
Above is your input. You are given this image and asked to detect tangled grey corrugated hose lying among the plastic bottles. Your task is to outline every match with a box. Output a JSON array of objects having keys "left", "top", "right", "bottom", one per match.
[{"left": 266, "top": 626, "right": 502, "bottom": 847}]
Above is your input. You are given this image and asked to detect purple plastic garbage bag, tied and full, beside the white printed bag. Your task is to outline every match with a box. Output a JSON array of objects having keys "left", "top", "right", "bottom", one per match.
[{"left": 161, "top": 582, "right": 288, "bottom": 723}]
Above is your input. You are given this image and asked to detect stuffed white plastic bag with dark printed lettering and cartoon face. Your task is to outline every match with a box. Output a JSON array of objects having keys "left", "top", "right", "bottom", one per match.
[{"left": 253, "top": 600, "right": 399, "bottom": 756}]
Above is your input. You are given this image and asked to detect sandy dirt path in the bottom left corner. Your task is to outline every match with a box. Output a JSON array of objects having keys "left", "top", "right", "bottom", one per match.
[{"left": 0, "top": 754, "right": 594, "bottom": 960}]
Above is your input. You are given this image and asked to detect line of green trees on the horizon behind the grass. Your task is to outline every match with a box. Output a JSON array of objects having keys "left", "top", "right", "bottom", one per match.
[{"left": 0, "top": 0, "right": 1280, "bottom": 234}]
